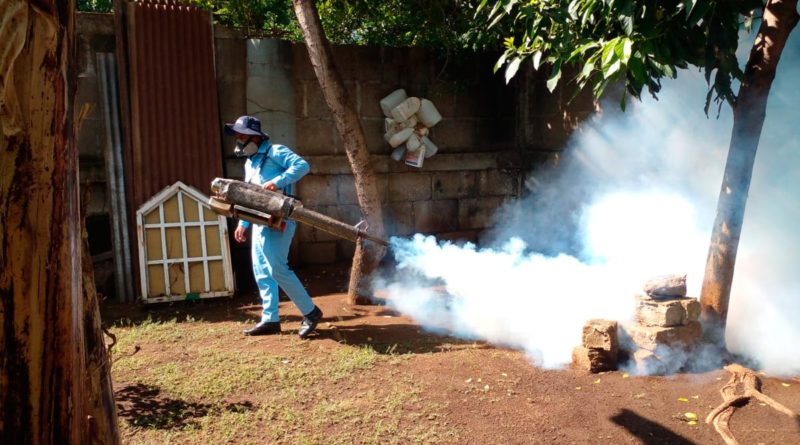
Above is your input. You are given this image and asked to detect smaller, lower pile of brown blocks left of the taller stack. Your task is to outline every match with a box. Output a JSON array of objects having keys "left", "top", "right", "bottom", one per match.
[{"left": 572, "top": 320, "right": 619, "bottom": 372}]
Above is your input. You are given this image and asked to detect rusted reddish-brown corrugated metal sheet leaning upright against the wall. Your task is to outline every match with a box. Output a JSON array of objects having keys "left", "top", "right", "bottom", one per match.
[{"left": 126, "top": 0, "right": 222, "bottom": 210}]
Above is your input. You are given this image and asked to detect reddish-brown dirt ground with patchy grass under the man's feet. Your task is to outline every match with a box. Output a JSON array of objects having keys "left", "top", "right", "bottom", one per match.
[{"left": 103, "top": 262, "right": 800, "bottom": 444}]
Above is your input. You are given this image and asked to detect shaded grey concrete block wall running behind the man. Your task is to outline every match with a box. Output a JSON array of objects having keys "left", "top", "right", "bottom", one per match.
[{"left": 75, "top": 13, "right": 595, "bottom": 270}]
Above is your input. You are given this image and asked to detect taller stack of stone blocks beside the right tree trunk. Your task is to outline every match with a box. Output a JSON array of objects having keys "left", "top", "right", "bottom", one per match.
[{"left": 626, "top": 275, "right": 703, "bottom": 374}]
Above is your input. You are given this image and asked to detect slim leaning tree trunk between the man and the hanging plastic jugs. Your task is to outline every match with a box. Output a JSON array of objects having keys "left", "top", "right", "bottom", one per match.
[{"left": 292, "top": 0, "right": 386, "bottom": 304}]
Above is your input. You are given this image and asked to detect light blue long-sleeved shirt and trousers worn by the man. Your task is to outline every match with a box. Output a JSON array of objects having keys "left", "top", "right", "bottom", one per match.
[{"left": 239, "top": 140, "right": 314, "bottom": 323}]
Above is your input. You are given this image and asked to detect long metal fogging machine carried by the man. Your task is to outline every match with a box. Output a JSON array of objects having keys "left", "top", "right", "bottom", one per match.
[{"left": 209, "top": 178, "right": 389, "bottom": 246}]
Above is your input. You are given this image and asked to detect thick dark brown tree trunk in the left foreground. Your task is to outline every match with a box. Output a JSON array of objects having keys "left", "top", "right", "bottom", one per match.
[{"left": 0, "top": 0, "right": 87, "bottom": 444}]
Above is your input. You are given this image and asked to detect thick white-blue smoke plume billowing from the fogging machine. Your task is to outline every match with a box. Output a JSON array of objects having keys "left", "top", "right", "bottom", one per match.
[{"left": 384, "top": 32, "right": 800, "bottom": 374}]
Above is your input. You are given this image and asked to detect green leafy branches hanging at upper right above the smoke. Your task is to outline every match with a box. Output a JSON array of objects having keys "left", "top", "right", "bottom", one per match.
[{"left": 477, "top": 0, "right": 763, "bottom": 112}]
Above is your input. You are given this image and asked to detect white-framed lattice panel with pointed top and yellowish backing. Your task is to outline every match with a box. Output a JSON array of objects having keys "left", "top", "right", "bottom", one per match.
[{"left": 136, "top": 181, "right": 234, "bottom": 303}]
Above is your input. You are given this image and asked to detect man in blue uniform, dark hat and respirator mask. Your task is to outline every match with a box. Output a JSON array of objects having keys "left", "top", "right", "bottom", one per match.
[{"left": 225, "top": 116, "right": 322, "bottom": 338}]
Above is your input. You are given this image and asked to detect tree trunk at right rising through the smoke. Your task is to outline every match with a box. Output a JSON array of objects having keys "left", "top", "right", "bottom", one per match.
[{"left": 700, "top": 0, "right": 798, "bottom": 346}]
